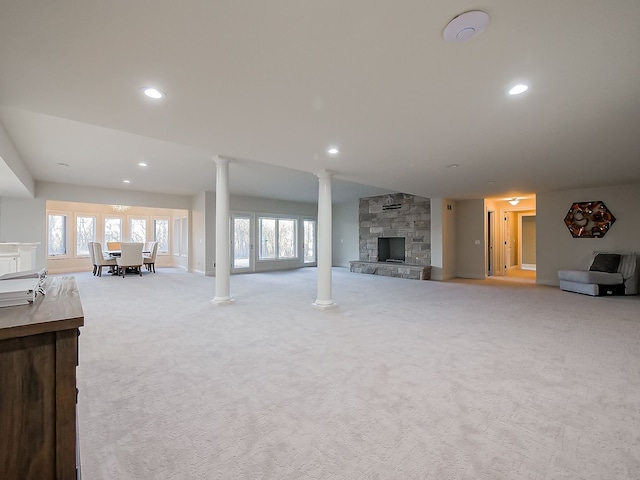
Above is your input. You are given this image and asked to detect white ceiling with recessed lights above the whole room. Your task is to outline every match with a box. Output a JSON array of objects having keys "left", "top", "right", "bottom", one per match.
[{"left": 0, "top": 0, "right": 640, "bottom": 201}]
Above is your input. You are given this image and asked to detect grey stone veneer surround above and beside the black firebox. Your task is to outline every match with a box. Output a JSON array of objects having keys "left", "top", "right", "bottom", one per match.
[{"left": 359, "top": 193, "right": 431, "bottom": 265}]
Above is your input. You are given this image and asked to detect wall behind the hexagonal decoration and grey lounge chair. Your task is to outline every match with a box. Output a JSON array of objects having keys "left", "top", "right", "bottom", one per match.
[{"left": 536, "top": 183, "right": 640, "bottom": 285}]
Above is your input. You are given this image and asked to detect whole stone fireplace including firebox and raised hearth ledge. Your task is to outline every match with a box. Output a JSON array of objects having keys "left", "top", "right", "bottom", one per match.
[{"left": 350, "top": 193, "right": 431, "bottom": 279}]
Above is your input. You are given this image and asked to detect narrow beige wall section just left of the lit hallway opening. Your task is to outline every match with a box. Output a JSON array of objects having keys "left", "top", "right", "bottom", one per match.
[{"left": 454, "top": 199, "right": 486, "bottom": 278}]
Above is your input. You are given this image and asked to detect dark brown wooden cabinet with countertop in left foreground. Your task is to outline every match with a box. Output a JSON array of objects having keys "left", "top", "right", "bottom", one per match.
[{"left": 0, "top": 277, "right": 84, "bottom": 480}]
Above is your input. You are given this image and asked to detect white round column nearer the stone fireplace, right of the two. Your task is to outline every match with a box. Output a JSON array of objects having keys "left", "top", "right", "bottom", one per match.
[{"left": 313, "top": 170, "right": 337, "bottom": 309}]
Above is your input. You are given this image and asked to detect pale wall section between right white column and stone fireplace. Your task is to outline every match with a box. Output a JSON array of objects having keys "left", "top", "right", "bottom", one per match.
[{"left": 331, "top": 200, "right": 360, "bottom": 268}]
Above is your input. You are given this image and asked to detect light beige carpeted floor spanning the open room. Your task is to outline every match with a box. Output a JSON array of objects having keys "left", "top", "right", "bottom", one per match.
[{"left": 75, "top": 268, "right": 640, "bottom": 480}]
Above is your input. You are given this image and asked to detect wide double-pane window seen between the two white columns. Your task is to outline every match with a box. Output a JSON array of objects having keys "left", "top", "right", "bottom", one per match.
[{"left": 258, "top": 217, "right": 298, "bottom": 260}]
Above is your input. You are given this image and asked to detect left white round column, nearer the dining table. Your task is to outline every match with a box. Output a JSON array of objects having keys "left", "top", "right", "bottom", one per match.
[{"left": 212, "top": 157, "right": 233, "bottom": 305}]
